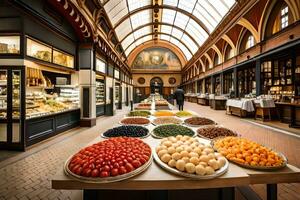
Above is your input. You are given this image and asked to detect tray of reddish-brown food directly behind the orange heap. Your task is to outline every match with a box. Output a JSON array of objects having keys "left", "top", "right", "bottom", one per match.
[{"left": 197, "top": 126, "right": 238, "bottom": 139}]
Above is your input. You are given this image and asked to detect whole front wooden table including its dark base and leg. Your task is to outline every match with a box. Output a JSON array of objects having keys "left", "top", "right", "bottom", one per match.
[{"left": 52, "top": 136, "right": 300, "bottom": 200}]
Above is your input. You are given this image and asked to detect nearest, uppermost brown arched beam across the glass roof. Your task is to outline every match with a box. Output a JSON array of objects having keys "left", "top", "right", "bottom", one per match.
[{"left": 114, "top": 5, "right": 210, "bottom": 35}]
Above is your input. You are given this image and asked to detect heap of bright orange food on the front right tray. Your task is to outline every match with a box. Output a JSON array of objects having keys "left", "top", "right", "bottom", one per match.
[{"left": 214, "top": 137, "right": 287, "bottom": 169}]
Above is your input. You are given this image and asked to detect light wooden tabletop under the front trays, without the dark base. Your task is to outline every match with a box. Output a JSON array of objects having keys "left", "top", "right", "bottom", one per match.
[{"left": 52, "top": 125, "right": 300, "bottom": 190}]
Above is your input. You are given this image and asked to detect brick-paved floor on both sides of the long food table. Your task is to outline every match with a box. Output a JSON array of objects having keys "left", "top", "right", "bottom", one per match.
[{"left": 0, "top": 103, "right": 300, "bottom": 200}]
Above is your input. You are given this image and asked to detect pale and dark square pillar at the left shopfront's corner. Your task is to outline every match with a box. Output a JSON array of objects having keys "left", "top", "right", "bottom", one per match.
[{"left": 78, "top": 44, "right": 96, "bottom": 127}]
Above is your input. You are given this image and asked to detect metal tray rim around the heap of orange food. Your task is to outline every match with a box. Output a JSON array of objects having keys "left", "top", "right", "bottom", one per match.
[{"left": 211, "top": 137, "right": 288, "bottom": 171}]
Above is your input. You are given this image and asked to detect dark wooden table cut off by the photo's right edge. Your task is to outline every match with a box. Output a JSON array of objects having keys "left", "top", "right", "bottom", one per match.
[{"left": 275, "top": 102, "right": 300, "bottom": 128}]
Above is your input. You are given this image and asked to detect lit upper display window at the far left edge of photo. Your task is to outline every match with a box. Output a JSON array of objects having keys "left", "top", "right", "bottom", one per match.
[{"left": 0, "top": 35, "right": 20, "bottom": 54}]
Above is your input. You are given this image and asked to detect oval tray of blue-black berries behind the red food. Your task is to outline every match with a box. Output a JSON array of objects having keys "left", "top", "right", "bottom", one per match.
[{"left": 102, "top": 125, "right": 149, "bottom": 138}]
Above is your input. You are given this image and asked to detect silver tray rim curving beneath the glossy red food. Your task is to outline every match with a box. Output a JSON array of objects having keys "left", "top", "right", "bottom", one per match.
[{"left": 64, "top": 153, "right": 153, "bottom": 183}]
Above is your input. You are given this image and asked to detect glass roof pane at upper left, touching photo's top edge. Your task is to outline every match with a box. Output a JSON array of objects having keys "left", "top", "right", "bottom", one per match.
[{"left": 104, "top": 0, "right": 128, "bottom": 26}]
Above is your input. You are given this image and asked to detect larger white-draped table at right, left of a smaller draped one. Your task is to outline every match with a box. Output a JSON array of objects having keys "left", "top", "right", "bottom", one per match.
[{"left": 226, "top": 99, "right": 255, "bottom": 117}]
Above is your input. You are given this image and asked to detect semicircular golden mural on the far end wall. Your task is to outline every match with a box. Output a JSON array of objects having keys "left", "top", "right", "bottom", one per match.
[{"left": 132, "top": 47, "right": 181, "bottom": 70}]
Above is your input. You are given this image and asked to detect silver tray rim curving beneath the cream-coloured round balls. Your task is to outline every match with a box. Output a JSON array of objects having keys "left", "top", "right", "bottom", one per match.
[{"left": 152, "top": 150, "right": 229, "bottom": 180}]
